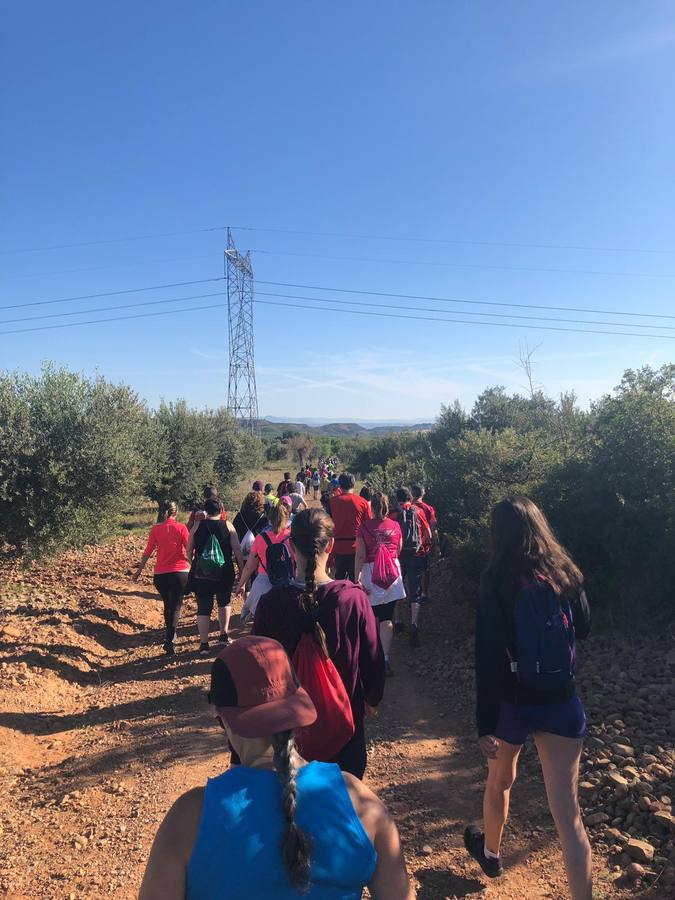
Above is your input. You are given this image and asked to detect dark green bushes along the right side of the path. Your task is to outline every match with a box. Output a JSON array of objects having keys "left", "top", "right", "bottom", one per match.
[{"left": 360, "top": 365, "right": 675, "bottom": 620}]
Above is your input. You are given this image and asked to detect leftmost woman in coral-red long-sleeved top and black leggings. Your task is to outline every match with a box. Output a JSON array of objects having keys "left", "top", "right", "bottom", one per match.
[{"left": 134, "top": 500, "right": 190, "bottom": 656}]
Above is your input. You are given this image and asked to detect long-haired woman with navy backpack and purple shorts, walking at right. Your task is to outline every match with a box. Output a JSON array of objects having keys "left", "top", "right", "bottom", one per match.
[{"left": 464, "top": 496, "right": 592, "bottom": 900}]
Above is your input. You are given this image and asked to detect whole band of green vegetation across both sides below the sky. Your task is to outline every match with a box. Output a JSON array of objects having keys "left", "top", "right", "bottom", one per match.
[{"left": 0, "top": 365, "right": 675, "bottom": 623}]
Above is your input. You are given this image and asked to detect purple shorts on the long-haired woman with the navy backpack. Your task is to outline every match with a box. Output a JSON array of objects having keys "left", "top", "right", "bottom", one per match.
[{"left": 495, "top": 696, "right": 586, "bottom": 745}]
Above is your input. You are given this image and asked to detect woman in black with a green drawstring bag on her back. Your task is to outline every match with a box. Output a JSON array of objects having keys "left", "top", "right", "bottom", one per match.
[{"left": 187, "top": 498, "right": 244, "bottom": 656}]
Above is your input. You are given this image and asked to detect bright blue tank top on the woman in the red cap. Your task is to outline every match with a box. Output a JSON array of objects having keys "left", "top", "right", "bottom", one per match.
[{"left": 187, "top": 762, "right": 377, "bottom": 900}]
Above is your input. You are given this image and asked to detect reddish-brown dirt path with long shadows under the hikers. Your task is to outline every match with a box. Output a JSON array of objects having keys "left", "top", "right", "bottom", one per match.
[{"left": 0, "top": 537, "right": 667, "bottom": 900}]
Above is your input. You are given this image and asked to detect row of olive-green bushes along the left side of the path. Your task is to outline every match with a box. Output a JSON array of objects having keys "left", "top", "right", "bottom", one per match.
[{"left": 0, "top": 366, "right": 262, "bottom": 557}]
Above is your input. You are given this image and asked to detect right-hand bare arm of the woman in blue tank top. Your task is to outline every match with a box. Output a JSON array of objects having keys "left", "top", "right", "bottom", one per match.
[{"left": 343, "top": 772, "right": 415, "bottom": 900}]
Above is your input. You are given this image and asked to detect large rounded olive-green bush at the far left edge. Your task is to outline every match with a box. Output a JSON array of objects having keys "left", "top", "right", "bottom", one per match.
[{"left": 0, "top": 366, "right": 148, "bottom": 556}]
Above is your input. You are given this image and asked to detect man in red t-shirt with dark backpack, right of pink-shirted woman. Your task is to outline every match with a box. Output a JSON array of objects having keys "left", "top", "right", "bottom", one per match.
[{"left": 389, "top": 488, "right": 432, "bottom": 647}]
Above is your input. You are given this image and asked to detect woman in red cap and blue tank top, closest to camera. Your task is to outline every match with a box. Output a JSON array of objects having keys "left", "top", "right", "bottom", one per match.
[{"left": 139, "top": 636, "right": 415, "bottom": 900}]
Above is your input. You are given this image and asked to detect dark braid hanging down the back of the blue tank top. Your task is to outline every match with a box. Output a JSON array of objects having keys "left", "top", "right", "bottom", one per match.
[{"left": 272, "top": 731, "right": 312, "bottom": 893}]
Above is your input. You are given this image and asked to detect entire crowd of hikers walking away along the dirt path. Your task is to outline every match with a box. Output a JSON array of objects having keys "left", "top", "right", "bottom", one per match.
[{"left": 135, "top": 468, "right": 591, "bottom": 900}]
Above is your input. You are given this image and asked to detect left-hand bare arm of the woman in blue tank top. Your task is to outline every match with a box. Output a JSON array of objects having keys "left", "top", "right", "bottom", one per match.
[{"left": 138, "top": 788, "right": 204, "bottom": 900}]
